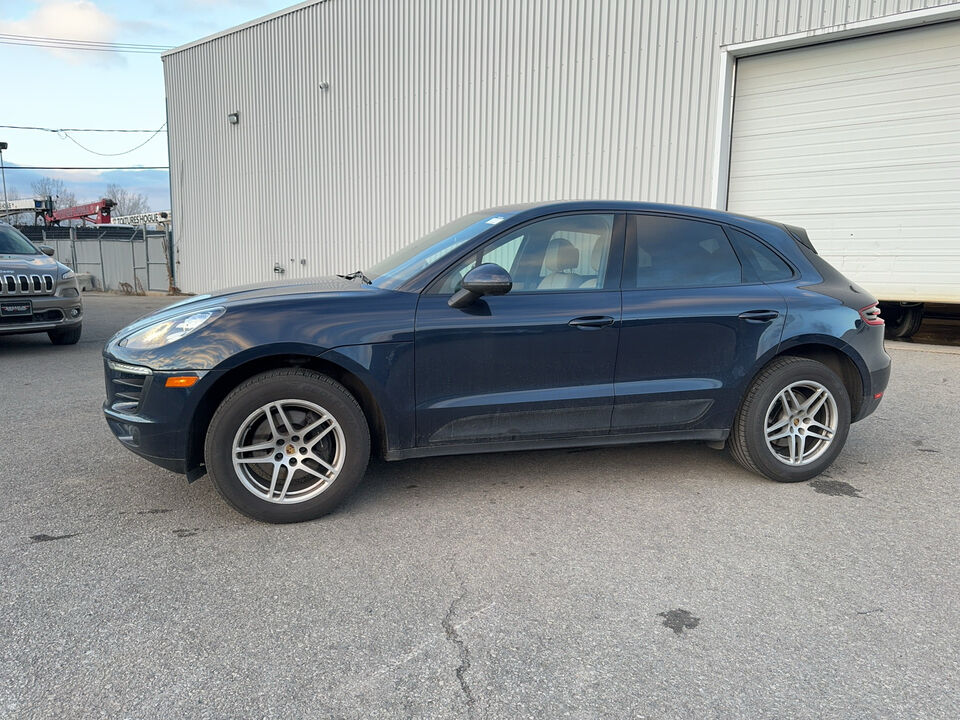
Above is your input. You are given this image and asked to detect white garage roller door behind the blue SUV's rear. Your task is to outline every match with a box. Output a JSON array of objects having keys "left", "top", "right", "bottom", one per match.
[{"left": 728, "top": 22, "right": 960, "bottom": 302}]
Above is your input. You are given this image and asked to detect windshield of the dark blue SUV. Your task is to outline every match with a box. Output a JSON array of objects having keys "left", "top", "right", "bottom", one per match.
[{"left": 364, "top": 210, "right": 514, "bottom": 290}]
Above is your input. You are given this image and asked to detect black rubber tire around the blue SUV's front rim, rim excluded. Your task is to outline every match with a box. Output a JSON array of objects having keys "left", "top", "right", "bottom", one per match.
[{"left": 204, "top": 368, "right": 370, "bottom": 523}]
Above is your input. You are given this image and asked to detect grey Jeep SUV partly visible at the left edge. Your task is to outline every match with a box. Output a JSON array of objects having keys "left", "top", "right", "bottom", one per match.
[{"left": 0, "top": 222, "right": 83, "bottom": 345}]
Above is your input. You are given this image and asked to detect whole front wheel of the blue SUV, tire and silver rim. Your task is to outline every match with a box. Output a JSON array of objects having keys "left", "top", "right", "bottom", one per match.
[{"left": 204, "top": 368, "right": 370, "bottom": 523}]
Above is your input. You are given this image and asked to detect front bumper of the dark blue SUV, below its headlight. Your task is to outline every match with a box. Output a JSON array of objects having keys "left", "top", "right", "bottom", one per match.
[{"left": 103, "top": 357, "right": 211, "bottom": 473}]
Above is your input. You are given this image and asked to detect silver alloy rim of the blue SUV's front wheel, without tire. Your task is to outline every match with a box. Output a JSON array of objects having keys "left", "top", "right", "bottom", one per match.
[{"left": 230, "top": 400, "right": 347, "bottom": 505}]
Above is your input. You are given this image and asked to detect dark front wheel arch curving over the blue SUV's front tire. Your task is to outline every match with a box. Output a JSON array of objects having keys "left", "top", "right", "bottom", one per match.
[{"left": 186, "top": 352, "right": 387, "bottom": 481}]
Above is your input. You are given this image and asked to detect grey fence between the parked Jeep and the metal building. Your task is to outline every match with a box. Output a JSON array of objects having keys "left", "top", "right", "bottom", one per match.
[{"left": 20, "top": 225, "right": 176, "bottom": 293}]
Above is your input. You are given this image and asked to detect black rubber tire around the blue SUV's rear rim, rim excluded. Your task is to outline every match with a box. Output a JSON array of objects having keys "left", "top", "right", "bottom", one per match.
[{"left": 729, "top": 356, "right": 850, "bottom": 482}]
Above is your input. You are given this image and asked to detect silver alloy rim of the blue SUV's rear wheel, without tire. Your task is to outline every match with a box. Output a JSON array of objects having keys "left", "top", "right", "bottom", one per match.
[{"left": 763, "top": 380, "right": 840, "bottom": 467}]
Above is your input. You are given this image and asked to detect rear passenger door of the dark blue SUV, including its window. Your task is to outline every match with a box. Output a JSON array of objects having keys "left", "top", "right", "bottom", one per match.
[{"left": 612, "top": 214, "right": 792, "bottom": 433}]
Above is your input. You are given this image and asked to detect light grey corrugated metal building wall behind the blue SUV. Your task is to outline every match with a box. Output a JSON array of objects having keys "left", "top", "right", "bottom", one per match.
[{"left": 164, "top": 0, "right": 949, "bottom": 292}]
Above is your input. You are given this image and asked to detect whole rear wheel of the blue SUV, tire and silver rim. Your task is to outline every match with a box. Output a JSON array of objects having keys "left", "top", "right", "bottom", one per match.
[{"left": 730, "top": 356, "right": 850, "bottom": 482}]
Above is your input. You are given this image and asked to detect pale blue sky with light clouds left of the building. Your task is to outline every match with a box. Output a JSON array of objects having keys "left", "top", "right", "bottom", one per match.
[{"left": 0, "top": 0, "right": 298, "bottom": 210}]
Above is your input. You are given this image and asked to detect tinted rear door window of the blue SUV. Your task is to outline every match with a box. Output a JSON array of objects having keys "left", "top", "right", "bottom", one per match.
[{"left": 625, "top": 215, "right": 741, "bottom": 288}]
